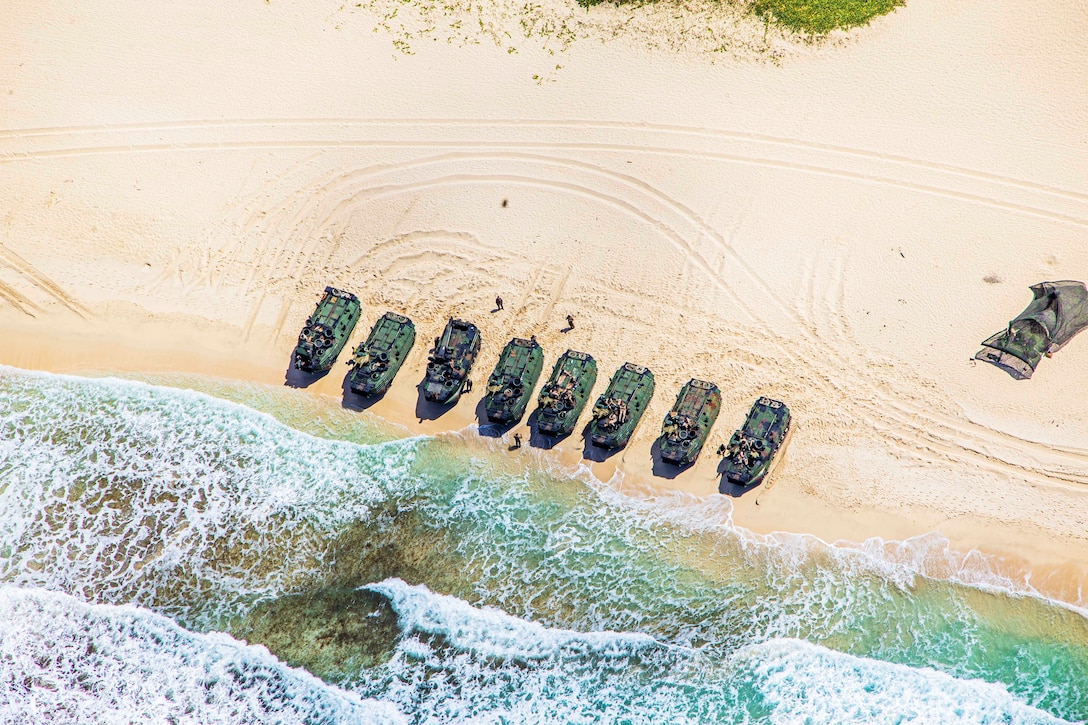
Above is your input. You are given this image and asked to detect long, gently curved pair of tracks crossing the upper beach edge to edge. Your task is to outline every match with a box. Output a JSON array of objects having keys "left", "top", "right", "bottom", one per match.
[{"left": 0, "top": 119, "right": 1088, "bottom": 228}]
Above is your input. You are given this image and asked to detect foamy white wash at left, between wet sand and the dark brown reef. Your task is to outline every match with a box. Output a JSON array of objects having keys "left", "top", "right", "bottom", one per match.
[{"left": 0, "top": 369, "right": 420, "bottom": 615}]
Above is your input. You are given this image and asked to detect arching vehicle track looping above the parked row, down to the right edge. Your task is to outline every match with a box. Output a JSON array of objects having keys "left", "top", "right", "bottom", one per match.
[{"left": 229, "top": 145, "right": 1088, "bottom": 484}]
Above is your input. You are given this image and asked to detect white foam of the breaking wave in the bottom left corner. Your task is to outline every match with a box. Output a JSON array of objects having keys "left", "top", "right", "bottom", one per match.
[{"left": 0, "top": 585, "right": 407, "bottom": 725}]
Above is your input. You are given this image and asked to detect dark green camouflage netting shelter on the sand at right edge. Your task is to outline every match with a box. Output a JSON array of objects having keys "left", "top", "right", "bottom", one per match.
[{"left": 975, "top": 280, "right": 1088, "bottom": 380}]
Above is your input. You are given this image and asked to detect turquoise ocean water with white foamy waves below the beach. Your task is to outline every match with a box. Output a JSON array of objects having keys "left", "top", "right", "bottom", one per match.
[{"left": 0, "top": 368, "right": 1088, "bottom": 724}]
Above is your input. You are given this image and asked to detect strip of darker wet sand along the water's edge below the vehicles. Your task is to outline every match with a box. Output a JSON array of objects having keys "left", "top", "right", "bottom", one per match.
[{"left": 0, "top": 309, "right": 1088, "bottom": 611}]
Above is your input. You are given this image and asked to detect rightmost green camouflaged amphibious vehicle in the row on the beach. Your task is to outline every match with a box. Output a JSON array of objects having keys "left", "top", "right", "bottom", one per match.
[{"left": 718, "top": 397, "right": 791, "bottom": 493}]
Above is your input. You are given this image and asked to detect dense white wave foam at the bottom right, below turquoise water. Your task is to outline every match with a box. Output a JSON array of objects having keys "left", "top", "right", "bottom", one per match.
[{"left": 732, "top": 639, "right": 1066, "bottom": 725}]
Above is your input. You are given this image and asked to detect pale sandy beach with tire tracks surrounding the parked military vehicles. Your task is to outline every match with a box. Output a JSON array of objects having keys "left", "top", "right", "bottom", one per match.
[{"left": 0, "top": 0, "right": 1088, "bottom": 605}]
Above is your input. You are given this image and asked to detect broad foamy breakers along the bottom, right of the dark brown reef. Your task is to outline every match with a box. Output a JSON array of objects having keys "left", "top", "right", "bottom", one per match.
[{"left": 362, "top": 579, "right": 1065, "bottom": 725}]
